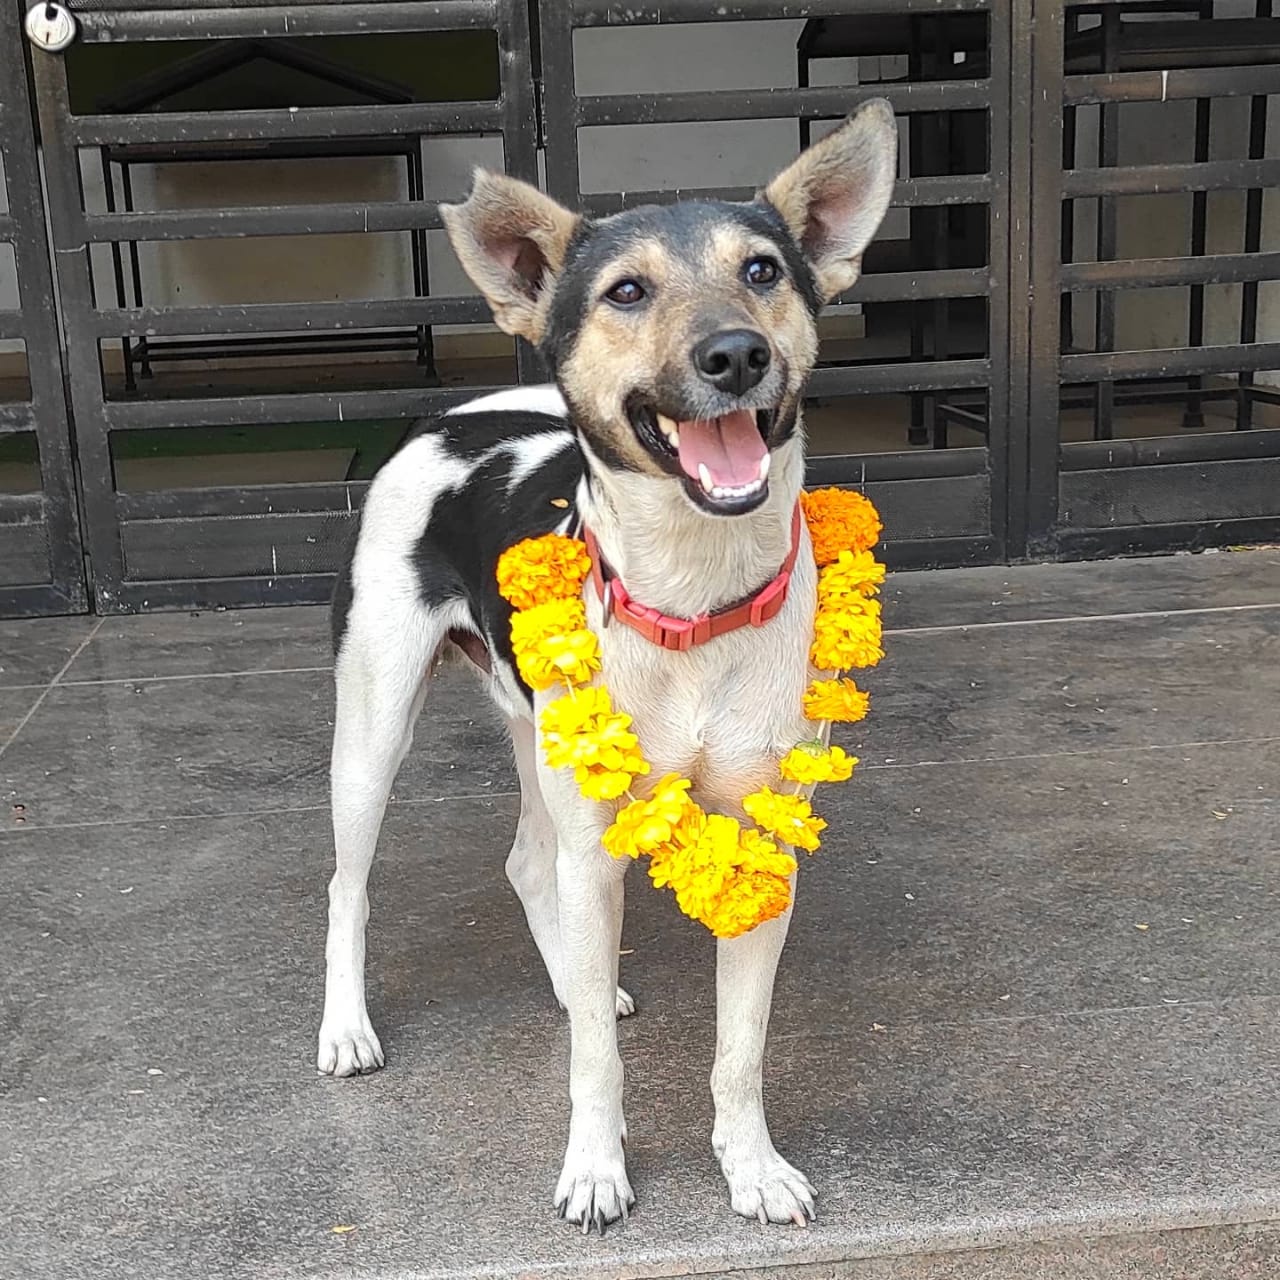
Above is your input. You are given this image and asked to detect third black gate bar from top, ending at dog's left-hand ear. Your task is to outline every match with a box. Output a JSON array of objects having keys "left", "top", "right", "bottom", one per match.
[{"left": 84, "top": 201, "right": 444, "bottom": 244}]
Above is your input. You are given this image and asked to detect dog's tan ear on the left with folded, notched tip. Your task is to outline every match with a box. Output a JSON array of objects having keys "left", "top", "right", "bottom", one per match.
[{"left": 440, "top": 169, "right": 579, "bottom": 344}]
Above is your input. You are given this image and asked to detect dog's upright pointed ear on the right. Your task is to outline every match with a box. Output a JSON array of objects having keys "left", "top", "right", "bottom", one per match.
[{"left": 762, "top": 97, "right": 897, "bottom": 302}]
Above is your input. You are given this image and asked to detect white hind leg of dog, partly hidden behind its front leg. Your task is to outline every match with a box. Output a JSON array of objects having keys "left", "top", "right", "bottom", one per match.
[{"left": 507, "top": 717, "right": 636, "bottom": 1018}]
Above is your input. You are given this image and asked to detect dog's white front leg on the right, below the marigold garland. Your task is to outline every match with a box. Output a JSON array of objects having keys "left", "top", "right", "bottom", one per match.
[{"left": 712, "top": 879, "right": 814, "bottom": 1226}]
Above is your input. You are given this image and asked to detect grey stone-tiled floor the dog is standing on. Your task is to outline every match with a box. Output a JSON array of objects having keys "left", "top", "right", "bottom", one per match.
[{"left": 0, "top": 550, "right": 1280, "bottom": 1280}]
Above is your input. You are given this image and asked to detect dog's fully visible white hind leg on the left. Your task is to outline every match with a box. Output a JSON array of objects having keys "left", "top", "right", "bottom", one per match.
[{"left": 316, "top": 599, "right": 448, "bottom": 1075}]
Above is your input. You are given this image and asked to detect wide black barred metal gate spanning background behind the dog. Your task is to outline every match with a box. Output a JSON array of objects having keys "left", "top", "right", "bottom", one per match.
[{"left": 10, "top": 0, "right": 1280, "bottom": 612}]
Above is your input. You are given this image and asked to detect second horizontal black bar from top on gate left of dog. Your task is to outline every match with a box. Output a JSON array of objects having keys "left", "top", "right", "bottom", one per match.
[{"left": 65, "top": 102, "right": 503, "bottom": 147}]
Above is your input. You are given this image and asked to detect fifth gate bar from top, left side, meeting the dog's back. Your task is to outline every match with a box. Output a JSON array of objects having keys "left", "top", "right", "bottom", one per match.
[{"left": 100, "top": 387, "right": 502, "bottom": 432}]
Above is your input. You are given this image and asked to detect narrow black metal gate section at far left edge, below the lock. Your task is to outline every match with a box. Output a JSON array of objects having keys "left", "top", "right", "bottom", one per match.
[{"left": 0, "top": 24, "right": 88, "bottom": 617}]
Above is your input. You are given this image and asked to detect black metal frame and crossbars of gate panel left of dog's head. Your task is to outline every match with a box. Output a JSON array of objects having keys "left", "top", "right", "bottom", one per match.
[{"left": 32, "top": 0, "right": 538, "bottom": 613}]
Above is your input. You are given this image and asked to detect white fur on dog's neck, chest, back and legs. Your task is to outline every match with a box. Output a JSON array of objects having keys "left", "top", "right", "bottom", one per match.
[{"left": 317, "top": 399, "right": 817, "bottom": 1228}]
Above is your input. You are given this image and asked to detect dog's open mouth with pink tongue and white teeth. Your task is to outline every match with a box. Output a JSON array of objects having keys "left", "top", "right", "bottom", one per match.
[{"left": 635, "top": 408, "right": 773, "bottom": 515}]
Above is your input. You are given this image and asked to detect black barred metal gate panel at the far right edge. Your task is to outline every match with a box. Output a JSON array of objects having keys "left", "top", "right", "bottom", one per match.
[{"left": 1011, "top": 0, "right": 1280, "bottom": 557}]
